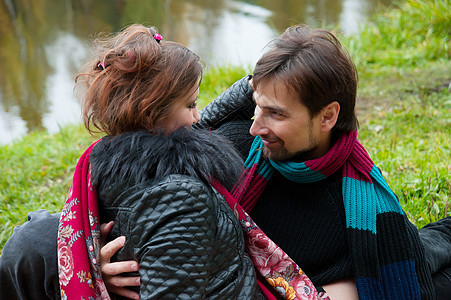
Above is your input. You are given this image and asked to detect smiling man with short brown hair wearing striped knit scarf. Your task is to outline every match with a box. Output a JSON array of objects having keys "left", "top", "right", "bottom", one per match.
[{"left": 100, "top": 26, "right": 451, "bottom": 299}]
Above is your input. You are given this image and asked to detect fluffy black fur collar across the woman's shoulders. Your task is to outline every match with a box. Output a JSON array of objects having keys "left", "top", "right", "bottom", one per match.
[{"left": 90, "top": 128, "right": 243, "bottom": 190}]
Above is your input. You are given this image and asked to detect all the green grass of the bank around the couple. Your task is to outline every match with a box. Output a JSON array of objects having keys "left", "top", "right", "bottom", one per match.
[{"left": 0, "top": 0, "right": 451, "bottom": 251}]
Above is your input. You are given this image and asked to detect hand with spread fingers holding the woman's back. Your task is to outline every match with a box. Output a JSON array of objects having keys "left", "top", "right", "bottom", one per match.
[{"left": 100, "top": 221, "right": 141, "bottom": 299}]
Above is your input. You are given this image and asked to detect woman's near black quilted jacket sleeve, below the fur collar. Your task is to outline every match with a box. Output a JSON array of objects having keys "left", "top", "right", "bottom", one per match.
[{"left": 130, "top": 179, "right": 217, "bottom": 299}]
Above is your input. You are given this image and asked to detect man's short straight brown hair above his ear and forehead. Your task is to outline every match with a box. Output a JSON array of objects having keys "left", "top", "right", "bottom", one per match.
[{"left": 253, "top": 25, "right": 358, "bottom": 131}]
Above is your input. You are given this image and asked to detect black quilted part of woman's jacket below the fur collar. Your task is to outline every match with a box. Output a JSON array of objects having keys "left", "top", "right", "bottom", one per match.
[{"left": 106, "top": 175, "right": 255, "bottom": 299}]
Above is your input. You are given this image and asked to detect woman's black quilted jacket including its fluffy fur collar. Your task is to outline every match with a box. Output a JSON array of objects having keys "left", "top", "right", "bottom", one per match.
[{"left": 90, "top": 128, "right": 256, "bottom": 299}]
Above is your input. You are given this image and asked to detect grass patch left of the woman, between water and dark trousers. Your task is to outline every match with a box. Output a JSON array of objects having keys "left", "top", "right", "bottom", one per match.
[{"left": 0, "top": 126, "right": 99, "bottom": 249}]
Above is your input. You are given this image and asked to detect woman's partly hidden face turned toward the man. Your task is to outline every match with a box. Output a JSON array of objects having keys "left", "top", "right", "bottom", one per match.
[{"left": 156, "top": 85, "right": 200, "bottom": 133}]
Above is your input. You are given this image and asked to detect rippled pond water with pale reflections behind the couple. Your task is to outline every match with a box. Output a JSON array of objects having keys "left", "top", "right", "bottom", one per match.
[{"left": 0, "top": 0, "right": 391, "bottom": 144}]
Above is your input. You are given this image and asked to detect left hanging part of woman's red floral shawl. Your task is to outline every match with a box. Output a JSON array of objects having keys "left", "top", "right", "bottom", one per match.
[{"left": 58, "top": 141, "right": 110, "bottom": 300}]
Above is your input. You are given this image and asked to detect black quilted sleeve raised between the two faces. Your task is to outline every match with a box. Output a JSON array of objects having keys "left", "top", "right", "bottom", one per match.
[{"left": 194, "top": 75, "right": 255, "bottom": 129}]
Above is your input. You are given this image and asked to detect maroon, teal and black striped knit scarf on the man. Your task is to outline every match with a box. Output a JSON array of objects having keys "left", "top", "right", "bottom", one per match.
[{"left": 233, "top": 131, "right": 420, "bottom": 300}]
